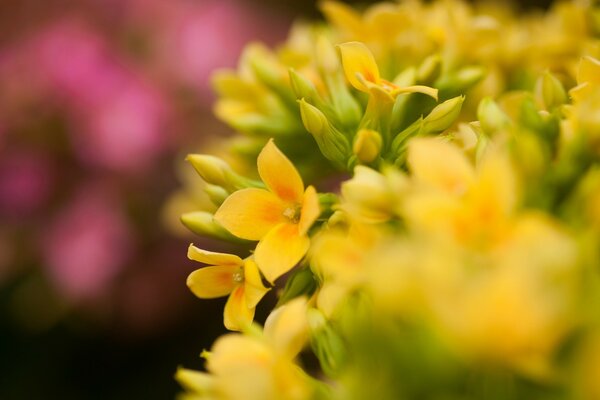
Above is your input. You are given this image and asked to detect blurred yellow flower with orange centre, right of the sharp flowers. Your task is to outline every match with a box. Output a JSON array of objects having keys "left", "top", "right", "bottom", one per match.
[{"left": 401, "top": 138, "right": 519, "bottom": 244}]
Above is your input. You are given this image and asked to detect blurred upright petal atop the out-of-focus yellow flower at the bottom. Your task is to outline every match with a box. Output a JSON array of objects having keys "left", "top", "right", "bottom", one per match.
[{"left": 264, "top": 297, "right": 309, "bottom": 359}]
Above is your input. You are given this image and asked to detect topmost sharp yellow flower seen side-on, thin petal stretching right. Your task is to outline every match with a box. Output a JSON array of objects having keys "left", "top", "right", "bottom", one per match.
[{"left": 338, "top": 42, "right": 438, "bottom": 100}]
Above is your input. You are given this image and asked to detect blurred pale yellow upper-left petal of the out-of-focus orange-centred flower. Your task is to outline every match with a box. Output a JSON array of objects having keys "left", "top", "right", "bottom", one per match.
[{"left": 408, "top": 138, "right": 474, "bottom": 194}]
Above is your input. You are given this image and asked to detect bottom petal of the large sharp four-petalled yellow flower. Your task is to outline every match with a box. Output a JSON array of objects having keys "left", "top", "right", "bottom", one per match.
[{"left": 254, "top": 223, "right": 310, "bottom": 283}]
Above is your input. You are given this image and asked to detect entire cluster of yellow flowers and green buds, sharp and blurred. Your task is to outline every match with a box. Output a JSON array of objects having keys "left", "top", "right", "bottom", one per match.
[{"left": 177, "top": 0, "right": 600, "bottom": 399}]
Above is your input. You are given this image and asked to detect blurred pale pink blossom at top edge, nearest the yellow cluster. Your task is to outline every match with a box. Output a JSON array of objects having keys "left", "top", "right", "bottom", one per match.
[{"left": 123, "top": 0, "right": 287, "bottom": 100}]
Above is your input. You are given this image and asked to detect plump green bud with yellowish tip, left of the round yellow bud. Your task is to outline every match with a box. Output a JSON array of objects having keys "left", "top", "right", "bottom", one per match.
[{"left": 298, "top": 99, "right": 351, "bottom": 168}]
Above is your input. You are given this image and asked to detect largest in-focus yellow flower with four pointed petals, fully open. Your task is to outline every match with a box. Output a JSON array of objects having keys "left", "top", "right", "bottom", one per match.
[{"left": 215, "top": 140, "right": 320, "bottom": 282}]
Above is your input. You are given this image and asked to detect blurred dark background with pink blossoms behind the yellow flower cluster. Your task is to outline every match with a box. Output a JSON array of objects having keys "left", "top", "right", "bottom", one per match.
[{"left": 0, "top": 0, "right": 548, "bottom": 400}]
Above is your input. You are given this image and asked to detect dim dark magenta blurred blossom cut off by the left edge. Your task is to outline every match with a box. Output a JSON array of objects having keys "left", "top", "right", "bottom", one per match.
[{"left": 0, "top": 151, "right": 54, "bottom": 220}]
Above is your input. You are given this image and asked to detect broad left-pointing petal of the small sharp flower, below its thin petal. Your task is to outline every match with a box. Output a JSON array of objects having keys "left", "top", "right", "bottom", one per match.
[{"left": 187, "top": 265, "right": 240, "bottom": 299}]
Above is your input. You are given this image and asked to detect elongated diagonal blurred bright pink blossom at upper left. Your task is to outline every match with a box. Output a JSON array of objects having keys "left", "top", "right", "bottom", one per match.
[{"left": 38, "top": 21, "right": 169, "bottom": 172}]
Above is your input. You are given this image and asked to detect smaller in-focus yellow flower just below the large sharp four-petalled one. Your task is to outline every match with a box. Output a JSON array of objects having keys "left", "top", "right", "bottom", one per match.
[{"left": 187, "top": 245, "right": 270, "bottom": 331}]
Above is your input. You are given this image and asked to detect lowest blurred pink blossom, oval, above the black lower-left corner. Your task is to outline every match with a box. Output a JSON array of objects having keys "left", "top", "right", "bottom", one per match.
[{"left": 41, "top": 188, "right": 133, "bottom": 300}]
